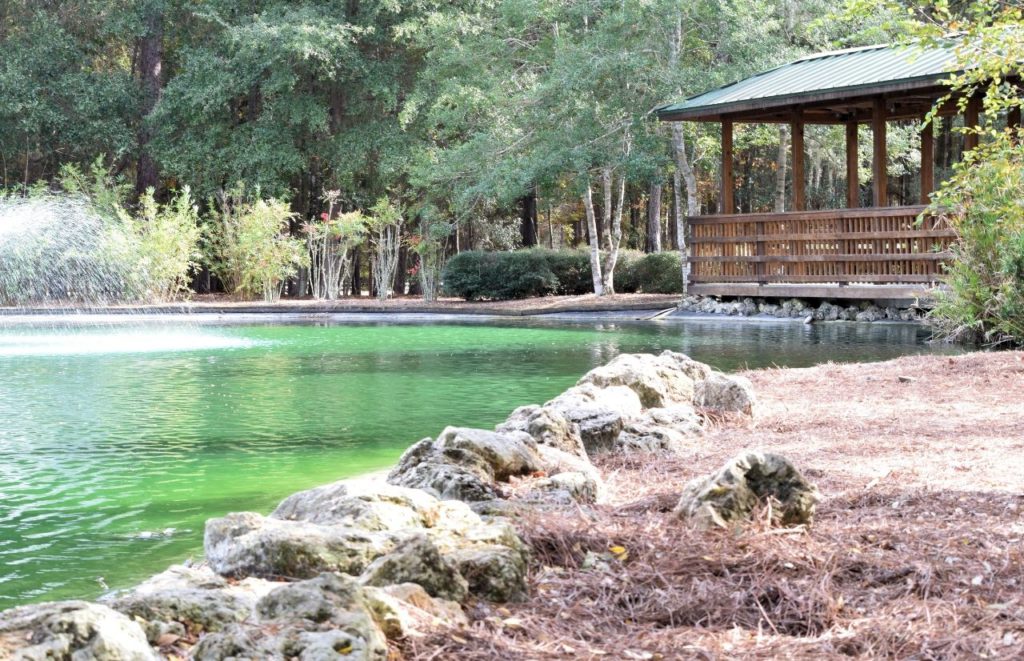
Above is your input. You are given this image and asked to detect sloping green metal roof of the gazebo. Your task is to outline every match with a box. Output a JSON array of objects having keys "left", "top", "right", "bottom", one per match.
[{"left": 656, "top": 44, "right": 955, "bottom": 121}]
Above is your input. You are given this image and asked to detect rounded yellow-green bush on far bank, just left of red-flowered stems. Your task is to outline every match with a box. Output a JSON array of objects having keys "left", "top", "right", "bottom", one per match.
[{"left": 205, "top": 185, "right": 308, "bottom": 302}]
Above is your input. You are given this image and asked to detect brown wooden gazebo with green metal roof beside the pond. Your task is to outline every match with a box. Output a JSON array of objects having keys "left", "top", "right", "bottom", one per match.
[{"left": 657, "top": 41, "right": 1020, "bottom": 300}]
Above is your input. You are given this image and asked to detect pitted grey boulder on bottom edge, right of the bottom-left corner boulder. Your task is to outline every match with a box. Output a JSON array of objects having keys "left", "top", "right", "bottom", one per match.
[{"left": 191, "top": 573, "right": 387, "bottom": 661}]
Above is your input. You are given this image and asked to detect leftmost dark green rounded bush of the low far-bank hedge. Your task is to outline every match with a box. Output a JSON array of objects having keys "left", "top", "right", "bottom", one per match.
[{"left": 441, "top": 251, "right": 558, "bottom": 301}]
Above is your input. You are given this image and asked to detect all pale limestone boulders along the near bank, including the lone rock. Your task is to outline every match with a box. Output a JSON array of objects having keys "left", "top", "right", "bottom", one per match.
[{"left": 0, "top": 351, "right": 817, "bottom": 661}]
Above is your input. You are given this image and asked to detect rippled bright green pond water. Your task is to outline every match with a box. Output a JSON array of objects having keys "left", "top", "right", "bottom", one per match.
[{"left": 0, "top": 319, "right": 954, "bottom": 608}]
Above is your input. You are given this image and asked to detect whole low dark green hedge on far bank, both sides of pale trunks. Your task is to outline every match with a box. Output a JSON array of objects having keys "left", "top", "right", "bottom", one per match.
[{"left": 441, "top": 249, "right": 682, "bottom": 301}]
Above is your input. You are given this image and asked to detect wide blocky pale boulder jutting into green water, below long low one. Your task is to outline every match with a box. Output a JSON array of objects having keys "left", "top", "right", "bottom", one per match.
[{"left": 203, "top": 512, "right": 397, "bottom": 578}]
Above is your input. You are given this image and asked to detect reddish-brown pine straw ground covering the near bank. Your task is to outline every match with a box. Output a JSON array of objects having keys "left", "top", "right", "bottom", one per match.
[{"left": 394, "top": 353, "right": 1024, "bottom": 659}]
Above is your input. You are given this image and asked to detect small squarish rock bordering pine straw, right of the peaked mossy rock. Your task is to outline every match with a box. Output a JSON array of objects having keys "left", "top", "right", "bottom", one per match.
[{"left": 446, "top": 545, "right": 526, "bottom": 603}]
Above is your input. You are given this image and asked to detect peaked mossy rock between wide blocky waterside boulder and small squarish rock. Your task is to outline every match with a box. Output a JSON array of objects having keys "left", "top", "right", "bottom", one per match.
[{"left": 360, "top": 534, "right": 469, "bottom": 602}]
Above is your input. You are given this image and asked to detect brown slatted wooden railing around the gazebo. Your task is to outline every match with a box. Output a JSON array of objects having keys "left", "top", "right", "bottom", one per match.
[{"left": 689, "top": 207, "right": 955, "bottom": 284}]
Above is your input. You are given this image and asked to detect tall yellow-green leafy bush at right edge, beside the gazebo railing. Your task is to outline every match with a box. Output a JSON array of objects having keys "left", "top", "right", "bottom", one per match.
[{"left": 930, "top": 134, "right": 1024, "bottom": 345}]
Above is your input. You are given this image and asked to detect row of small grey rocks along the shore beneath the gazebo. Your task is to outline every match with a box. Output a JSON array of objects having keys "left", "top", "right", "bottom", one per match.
[{"left": 678, "top": 296, "right": 925, "bottom": 321}]
